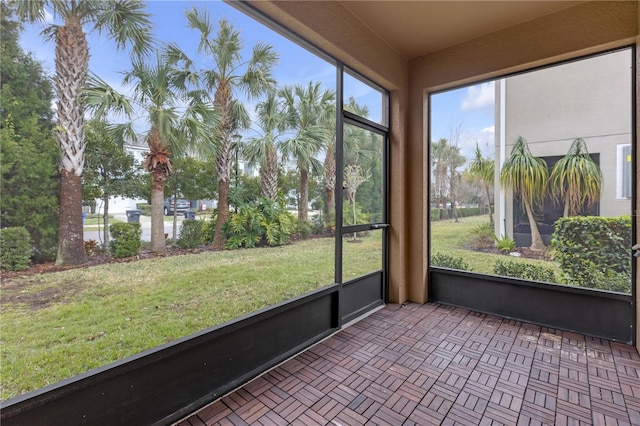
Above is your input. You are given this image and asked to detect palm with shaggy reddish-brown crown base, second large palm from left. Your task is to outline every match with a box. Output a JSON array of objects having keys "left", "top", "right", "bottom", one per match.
[{"left": 87, "top": 55, "right": 210, "bottom": 254}]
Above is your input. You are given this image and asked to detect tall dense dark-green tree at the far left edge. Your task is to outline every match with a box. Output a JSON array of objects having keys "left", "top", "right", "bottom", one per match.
[{"left": 0, "top": 2, "right": 60, "bottom": 261}]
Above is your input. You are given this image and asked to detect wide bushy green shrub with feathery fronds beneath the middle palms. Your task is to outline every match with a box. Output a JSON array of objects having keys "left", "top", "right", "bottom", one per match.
[{"left": 222, "top": 198, "right": 296, "bottom": 249}]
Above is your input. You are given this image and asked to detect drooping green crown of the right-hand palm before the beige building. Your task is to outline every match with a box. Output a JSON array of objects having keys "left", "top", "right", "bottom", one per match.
[{"left": 549, "top": 138, "right": 602, "bottom": 217}]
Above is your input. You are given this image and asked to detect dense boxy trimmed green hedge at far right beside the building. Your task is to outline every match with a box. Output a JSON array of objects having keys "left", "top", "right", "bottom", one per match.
[{"left": 551, "top": 216, "right": 631, "bottom": 288}]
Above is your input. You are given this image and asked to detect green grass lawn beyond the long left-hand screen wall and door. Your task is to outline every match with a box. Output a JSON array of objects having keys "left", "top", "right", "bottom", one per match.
[{"left": 0, "top": 233, "right": 380, "bottom": 400}]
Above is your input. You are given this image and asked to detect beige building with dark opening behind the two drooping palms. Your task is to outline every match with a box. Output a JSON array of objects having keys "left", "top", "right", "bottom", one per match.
[{"left": 495, "top": 49, "right": 632, "bottom": 240}]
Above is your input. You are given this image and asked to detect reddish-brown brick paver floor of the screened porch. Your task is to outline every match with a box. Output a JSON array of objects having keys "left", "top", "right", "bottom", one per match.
[{"left": 179, "top": 303, "right": 640, "bottom": 426}]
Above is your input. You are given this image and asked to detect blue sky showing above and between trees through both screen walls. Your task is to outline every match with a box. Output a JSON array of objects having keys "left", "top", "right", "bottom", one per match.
[{"left": 16, "top": 0, "right": 494, "bottom": 163}]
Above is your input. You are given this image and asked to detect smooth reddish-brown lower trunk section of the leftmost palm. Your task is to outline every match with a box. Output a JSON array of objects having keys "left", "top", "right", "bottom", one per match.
[{"left": 56, "top": 169, "right": 87, "bottom": 265}]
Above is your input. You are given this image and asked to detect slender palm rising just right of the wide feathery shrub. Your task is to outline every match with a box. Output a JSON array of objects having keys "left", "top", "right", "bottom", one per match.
[{"left": 281, "top": 82, "right": 335, "bottom": 222}]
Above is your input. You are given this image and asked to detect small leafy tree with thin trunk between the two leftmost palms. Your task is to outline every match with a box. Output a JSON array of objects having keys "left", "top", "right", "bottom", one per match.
[{"left": 82, "top": 119, "right": 140, "bottom": 252}]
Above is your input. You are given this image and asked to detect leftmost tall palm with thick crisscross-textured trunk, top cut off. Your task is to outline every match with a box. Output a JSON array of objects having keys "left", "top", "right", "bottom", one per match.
[{"left": 15, "top": 0, "right": 151, "bottom": 265}]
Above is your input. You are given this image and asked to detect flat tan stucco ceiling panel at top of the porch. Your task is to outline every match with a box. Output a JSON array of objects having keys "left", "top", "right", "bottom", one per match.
[{"left": 340, "top": 0, "right": 584, "bottom": 58}]
